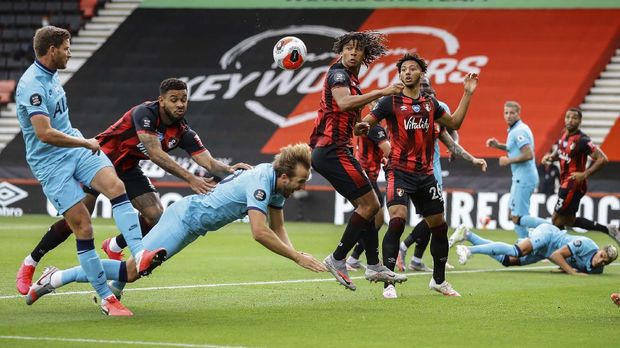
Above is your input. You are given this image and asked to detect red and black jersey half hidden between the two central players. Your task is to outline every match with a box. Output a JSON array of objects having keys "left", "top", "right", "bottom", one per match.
[{"left": 355, "top": 125, "right": 387, "bottom": 181}]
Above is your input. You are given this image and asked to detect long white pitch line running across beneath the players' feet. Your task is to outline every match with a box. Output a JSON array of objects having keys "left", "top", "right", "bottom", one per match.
[{"left": 0, "top": 263, "right": 620, "bottom": 300}]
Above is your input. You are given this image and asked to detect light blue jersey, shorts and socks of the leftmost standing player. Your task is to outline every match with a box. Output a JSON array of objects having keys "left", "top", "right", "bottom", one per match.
[{"left": 15, "top": 60, "right": 143, "bottom": 298}]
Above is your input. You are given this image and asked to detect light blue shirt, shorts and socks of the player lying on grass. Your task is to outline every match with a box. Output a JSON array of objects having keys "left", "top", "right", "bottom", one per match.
[{"left": 467, "top": 223, "right": 603, "bottom": 273}]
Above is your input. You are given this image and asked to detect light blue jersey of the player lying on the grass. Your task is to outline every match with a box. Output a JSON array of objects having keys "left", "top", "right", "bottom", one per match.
[{"left": 522, "top": 224, "right": 603, "bottom": 273}]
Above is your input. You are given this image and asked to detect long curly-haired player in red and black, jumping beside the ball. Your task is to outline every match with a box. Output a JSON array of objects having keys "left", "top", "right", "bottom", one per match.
[{"left": 310, "top": 32, "right": 407, "bottom": 290}]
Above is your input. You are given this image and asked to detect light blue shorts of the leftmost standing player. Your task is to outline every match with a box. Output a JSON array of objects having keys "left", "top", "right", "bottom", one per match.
[{"left": 37, "top": 147, "right": 112, "bottom": 215}]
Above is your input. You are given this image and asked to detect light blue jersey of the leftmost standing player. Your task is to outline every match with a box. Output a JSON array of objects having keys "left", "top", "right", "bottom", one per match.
[{"left": 15, "top": 61, "right": 82, "bottom": 178}]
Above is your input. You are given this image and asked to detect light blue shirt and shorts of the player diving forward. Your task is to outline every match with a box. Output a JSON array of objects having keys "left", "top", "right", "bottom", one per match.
[{"left": 143, "top": 163, "right": 285, "bottom": 258}]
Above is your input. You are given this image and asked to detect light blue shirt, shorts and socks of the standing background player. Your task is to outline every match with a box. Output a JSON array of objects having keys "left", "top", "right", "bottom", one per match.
[{"left": 506, "top": 120, "right": 545, "bottom": 238}]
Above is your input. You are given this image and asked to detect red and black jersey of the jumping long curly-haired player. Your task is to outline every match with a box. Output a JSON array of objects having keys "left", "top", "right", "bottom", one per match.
[{"left": 310, "top": 63, "right": 362, "bottom": 148}]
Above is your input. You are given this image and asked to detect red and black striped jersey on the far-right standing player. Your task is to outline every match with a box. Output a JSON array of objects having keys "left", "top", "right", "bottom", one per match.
[{"left": 558, "top": 130, "right": 598, "bottom": 192}]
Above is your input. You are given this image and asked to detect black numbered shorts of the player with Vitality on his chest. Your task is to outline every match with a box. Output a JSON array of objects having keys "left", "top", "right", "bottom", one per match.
[{"left": 385, "top": 169, "right": 444, "bottom": 217}]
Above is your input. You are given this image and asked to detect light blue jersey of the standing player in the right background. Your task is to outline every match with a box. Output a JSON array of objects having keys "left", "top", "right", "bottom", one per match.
[{"left": 506, "top": 120, "right": 538, "bottom": 186}]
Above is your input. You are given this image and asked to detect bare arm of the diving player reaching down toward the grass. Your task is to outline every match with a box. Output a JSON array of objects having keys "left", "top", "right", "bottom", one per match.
[{"left": 248, "top": 209, "right": 327, "bottom": 272}]
